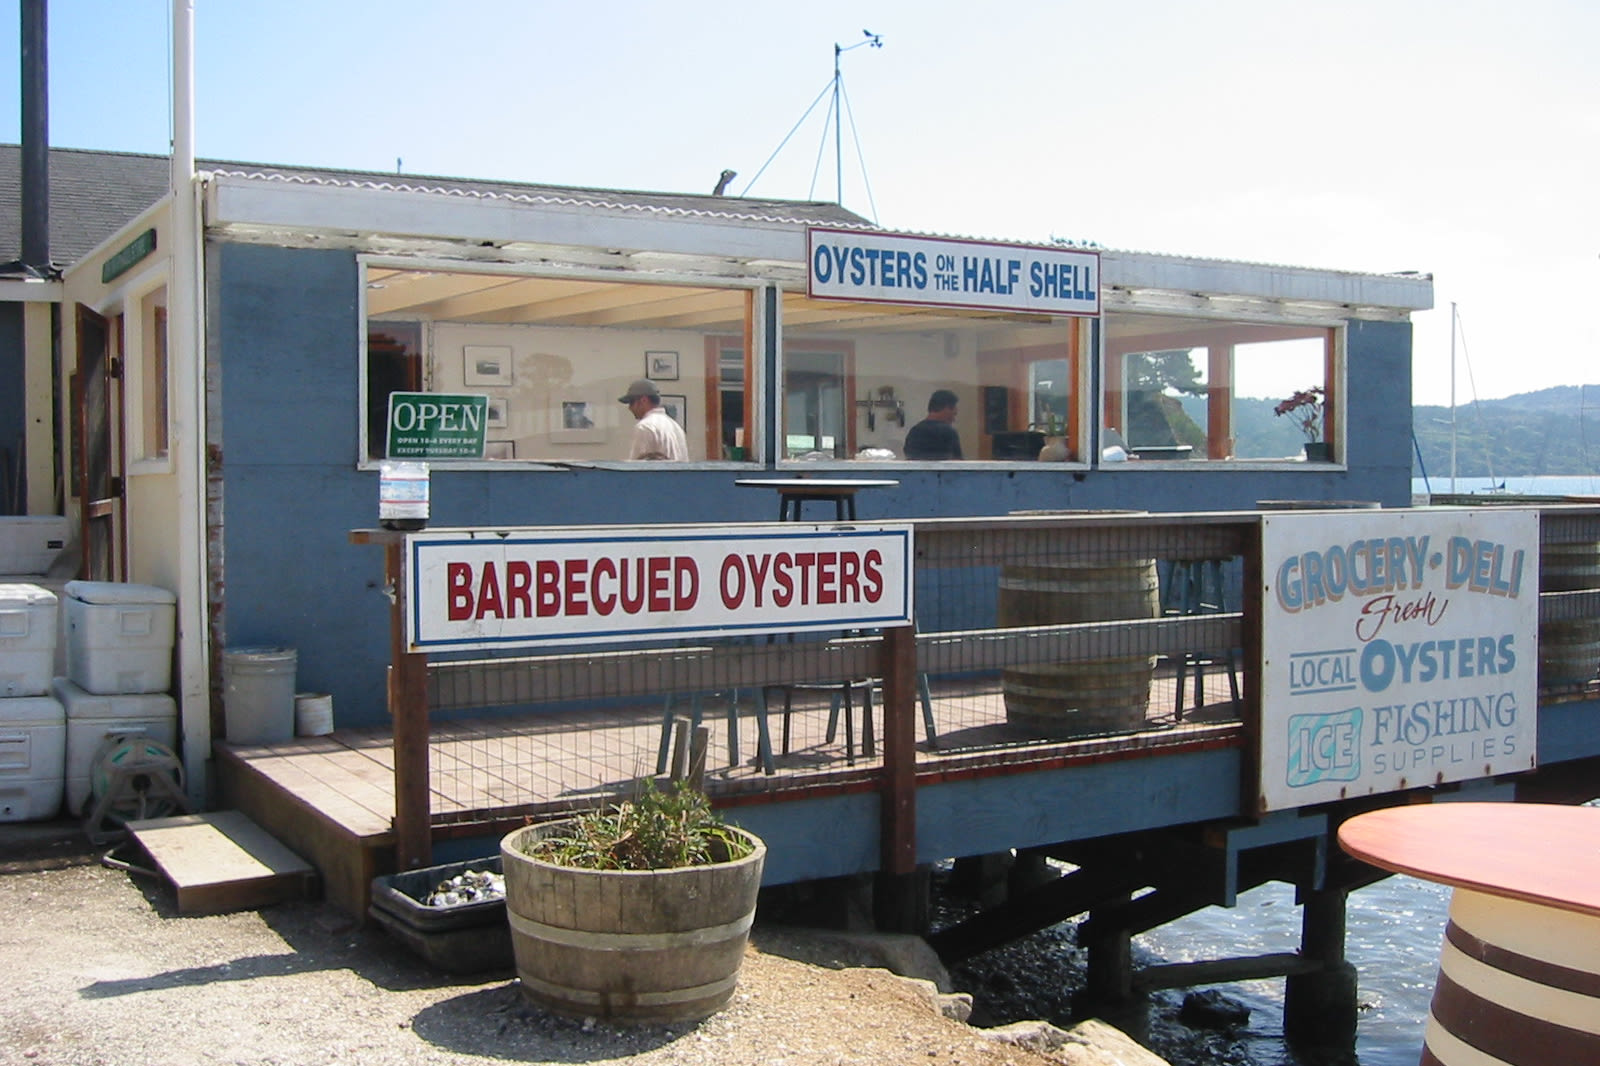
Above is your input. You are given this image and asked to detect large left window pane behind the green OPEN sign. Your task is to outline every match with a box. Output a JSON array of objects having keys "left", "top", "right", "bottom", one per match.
[{"left": 366, "top": 264, "right": 754, "bottom": 463}]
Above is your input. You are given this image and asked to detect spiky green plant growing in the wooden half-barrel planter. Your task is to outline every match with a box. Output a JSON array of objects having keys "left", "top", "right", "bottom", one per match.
[{"left": 526, "top": 778, "right": 754, "bottom": 871}]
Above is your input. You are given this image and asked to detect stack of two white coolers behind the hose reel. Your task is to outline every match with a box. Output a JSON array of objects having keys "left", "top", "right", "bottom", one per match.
[{"left": 51, "top": 581, "right": 178, "bottom": 815}]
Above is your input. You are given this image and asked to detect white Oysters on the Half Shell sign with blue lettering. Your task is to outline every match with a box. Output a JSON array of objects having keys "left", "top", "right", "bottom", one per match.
[{"left": 806, "top": 227, "right": 1099, "bottom": 315}]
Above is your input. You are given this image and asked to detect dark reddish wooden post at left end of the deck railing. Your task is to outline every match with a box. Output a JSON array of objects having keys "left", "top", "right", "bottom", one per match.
[{"left": 384, "top": 538, "right": 434, "bottom": 871}]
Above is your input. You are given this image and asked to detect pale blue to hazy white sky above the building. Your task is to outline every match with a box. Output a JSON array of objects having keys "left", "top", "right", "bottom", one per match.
[{"left": 0, "top": 0, "right": 1600, "bottom": 407}]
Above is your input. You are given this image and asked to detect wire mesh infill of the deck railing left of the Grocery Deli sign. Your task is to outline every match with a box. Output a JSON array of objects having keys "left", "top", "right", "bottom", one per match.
[{"left": 406, "top": 515, "right": 1248, "bottom": 824}]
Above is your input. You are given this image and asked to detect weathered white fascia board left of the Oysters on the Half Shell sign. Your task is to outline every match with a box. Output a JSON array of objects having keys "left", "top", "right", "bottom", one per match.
[{"left": 206, "top": 174, "right": 805, "bottom": 262}]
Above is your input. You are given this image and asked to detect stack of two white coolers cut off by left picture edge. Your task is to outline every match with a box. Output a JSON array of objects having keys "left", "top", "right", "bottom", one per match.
[{"left": 0, "top": 584, "right": 66, "bottom": 821}]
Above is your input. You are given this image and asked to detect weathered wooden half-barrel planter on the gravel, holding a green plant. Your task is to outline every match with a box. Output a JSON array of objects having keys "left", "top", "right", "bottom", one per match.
[{"left": 501, "top": 821, "right": 766, "bottom": 1023}]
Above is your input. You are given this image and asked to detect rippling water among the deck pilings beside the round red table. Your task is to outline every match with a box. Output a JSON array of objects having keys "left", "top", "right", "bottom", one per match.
[{"left": 1134, "top": 876, "right": 1450, "bottom": 1066}]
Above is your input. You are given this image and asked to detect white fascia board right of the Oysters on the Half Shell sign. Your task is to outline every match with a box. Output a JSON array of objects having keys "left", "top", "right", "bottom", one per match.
[{"left": 1101, "top": 251, "right": 1434, "bottom": 312}]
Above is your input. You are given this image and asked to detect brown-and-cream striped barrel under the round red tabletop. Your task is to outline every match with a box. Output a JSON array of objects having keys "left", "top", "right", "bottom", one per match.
[{"left": 1421, "top": 883, "right": 1600, "bottom": 1066}]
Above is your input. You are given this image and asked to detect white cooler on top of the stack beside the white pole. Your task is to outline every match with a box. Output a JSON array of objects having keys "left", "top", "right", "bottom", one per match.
[{"left": 62, "top": 581, "right": 178, "bottom": 695}]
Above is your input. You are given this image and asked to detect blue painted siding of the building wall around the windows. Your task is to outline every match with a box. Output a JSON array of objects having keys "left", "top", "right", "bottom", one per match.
[{"left": 208, "top": 243, "right": 1411, "bottom": 725}]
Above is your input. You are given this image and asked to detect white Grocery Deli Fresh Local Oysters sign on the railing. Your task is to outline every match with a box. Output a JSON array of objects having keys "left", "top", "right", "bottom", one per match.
[{"left": 1259, "top": 507, "right": 1539, "bottom": 810}]
